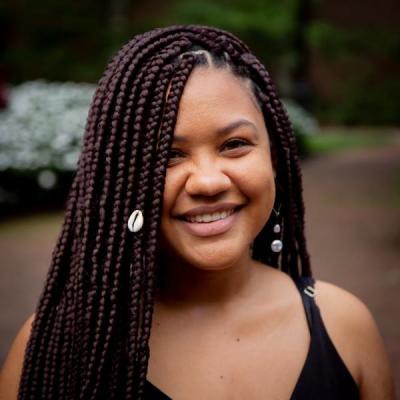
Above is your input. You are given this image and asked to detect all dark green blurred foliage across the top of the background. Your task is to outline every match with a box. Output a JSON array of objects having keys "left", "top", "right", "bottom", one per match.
[{"left": 0, "top": 0, "right": 400, "bottom": 124}]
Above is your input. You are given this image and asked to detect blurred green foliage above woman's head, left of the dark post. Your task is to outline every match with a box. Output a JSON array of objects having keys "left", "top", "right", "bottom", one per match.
[{"left": 0, "top": 0, "right": 297, "bottom": 83}]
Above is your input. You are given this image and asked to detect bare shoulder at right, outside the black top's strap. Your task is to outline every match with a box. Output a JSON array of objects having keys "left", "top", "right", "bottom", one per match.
[{"left": 315, "top": 281, "right": 395, "bottom": 400}]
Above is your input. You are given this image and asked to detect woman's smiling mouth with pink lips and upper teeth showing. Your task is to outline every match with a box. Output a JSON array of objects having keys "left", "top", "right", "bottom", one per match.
[{"left": 179, "top": 209, "right": 240, "bottom": 237}]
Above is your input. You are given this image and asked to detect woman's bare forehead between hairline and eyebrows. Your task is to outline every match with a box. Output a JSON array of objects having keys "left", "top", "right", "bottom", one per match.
[{"left": 175, "top": 67, "right": 264, "bottom": 133}]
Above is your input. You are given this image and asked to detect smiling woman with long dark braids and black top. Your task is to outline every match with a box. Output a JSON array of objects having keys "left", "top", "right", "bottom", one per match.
[{"left": 1, "top": 26, "right": 394, "bottom": 399}]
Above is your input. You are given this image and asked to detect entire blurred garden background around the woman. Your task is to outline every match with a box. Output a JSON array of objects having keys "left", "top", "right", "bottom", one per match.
[{"left": 0, "top": 0, "right": 400, "bottom": 392}]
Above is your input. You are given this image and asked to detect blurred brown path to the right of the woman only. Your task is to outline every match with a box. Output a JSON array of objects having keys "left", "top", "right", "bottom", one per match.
[{"left": 303, "top": 143, "right": 400, "bottom": 395}]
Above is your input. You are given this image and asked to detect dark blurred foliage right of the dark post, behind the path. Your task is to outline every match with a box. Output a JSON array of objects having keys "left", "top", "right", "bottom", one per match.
[{"left": 308, "top": 21, "right": 400, "bottom": 125}]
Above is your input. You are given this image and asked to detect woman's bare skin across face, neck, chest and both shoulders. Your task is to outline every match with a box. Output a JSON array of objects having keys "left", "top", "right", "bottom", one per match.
[{"left": 0, "top": 68, "right": 394, "bottom": 400}]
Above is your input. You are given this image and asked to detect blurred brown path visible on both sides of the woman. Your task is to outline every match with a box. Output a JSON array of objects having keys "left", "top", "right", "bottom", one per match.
[{"left": 0, "top": 141, "right": 400, "bottom": 392}]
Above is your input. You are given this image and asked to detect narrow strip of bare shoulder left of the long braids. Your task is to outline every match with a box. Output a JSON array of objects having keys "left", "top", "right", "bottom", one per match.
[{"left": 0, "top": 314, "right": 35, "bottom": 400}]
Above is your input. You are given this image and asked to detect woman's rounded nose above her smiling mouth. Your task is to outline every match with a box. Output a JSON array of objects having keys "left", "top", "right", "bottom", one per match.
[{"left": 185, "top": 161, "right": 231, "bottom": 196}]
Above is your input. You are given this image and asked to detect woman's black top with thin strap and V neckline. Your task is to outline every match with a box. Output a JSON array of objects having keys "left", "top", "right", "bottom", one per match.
[{"left": 144, "top": 277, "right": 360, "bottom": 400}]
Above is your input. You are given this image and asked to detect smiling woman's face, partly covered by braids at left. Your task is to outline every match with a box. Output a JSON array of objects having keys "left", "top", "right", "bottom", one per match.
[{"left": 161, "top": 67, "right": 275, "bottom": 270}]
